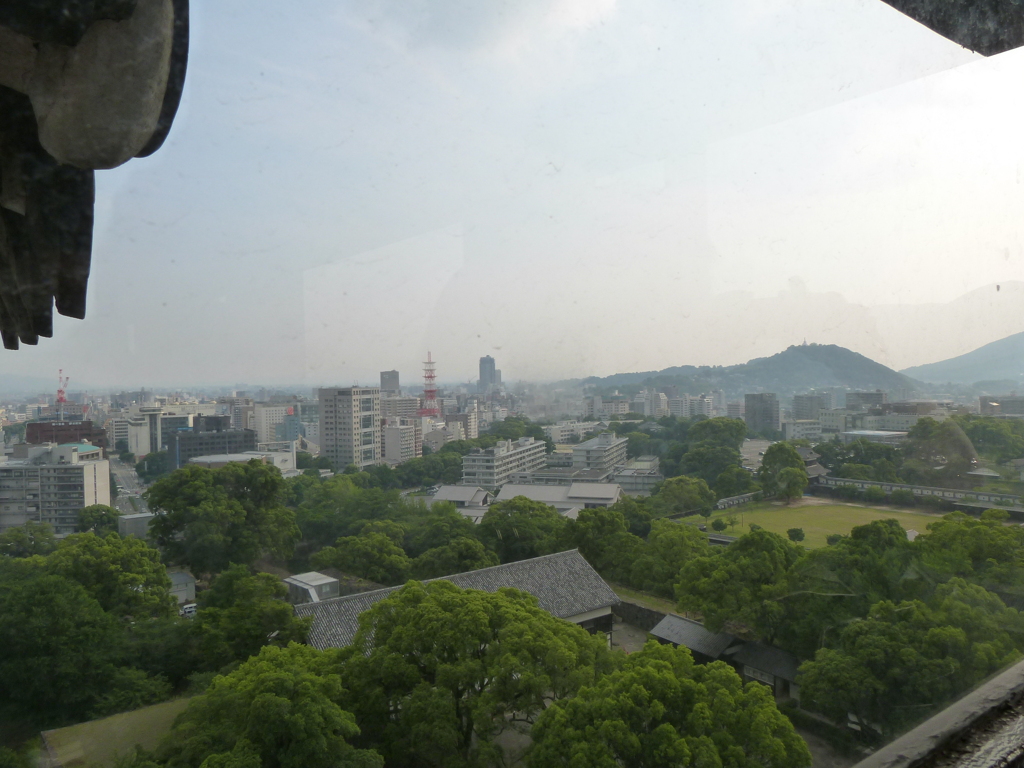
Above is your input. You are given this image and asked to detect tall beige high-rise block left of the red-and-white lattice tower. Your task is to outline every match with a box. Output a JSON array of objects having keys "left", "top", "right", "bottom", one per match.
[{"left": 317, "top": 387, "right": 381, "bottom": 470}]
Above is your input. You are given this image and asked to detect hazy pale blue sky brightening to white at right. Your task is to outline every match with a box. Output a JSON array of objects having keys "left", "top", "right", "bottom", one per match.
[{"left": 8, "top": 0, "right": 1024, "bottom": 387}]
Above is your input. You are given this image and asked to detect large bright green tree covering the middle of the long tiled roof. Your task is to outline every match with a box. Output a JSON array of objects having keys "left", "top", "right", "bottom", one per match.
[{"left": 342, "top": 581, "right": 610, "bottom": 768}]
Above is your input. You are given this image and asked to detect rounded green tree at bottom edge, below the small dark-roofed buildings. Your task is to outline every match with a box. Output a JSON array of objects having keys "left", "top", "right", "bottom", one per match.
[{"left": 528, "top": 641, "right": 811, "bottom": 768}]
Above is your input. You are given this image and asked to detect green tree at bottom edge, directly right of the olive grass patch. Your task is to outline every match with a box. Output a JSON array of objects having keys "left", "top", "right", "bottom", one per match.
[{"left": 158, "top": 643, "right": 384, "bottom": 768}]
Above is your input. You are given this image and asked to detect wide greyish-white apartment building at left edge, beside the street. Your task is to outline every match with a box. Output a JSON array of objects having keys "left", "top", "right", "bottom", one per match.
[{"left": 0, "top": 442, "right": 111, "bottom": 538}]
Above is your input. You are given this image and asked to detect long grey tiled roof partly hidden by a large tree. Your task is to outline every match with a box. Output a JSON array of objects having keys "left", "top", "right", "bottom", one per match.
[{"left": 295, "top": 550, "right": 618, "bottom": 650}]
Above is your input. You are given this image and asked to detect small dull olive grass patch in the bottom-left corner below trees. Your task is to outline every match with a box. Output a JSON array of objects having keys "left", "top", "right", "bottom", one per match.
[{"left": 43, "top": 698, "right": 188, "bottom": 766}]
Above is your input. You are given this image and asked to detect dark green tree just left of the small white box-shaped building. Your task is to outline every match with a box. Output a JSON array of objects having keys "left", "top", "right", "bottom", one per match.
[{"left": 191, "top": 565, "right": 309, "bottom": 671}]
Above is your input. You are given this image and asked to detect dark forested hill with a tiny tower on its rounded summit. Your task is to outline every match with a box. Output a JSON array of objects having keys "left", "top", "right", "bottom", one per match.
[{"left": 583, "top": 344, "right": 920, "bottom": 395}]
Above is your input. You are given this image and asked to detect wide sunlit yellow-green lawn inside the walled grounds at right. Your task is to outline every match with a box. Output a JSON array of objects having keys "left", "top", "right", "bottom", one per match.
[{"left": 708, "top": 500, "right": 939, "bottom": 548}]
